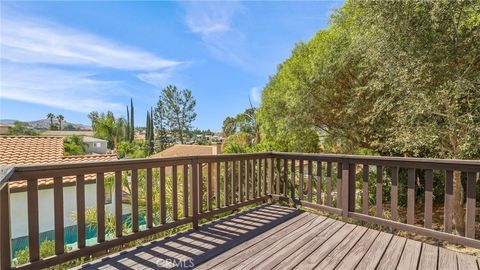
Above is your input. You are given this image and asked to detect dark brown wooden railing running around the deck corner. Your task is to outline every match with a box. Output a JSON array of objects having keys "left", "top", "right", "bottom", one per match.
[{"left": 0, "top": 152, "right": 480, "bottom": 269}]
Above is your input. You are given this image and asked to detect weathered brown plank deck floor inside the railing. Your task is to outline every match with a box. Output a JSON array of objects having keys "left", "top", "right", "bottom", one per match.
[{"left": 82, "top": 204, "right": 480, "bottom": 270}]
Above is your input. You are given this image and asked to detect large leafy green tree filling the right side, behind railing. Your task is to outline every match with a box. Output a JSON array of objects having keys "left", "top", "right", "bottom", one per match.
[{"left": 258, "top": 1, "right": 480, "bottom": 234}]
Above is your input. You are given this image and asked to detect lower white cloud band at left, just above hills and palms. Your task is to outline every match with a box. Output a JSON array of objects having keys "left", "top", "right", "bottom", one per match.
[{"left": 0, "top": 63, "right": 126, "bottom": 113}]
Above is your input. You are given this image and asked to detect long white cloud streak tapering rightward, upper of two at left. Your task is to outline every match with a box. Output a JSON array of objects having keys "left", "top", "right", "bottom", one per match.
[{"left": 0, "top": 15, "right": 181, "bottom": 70}]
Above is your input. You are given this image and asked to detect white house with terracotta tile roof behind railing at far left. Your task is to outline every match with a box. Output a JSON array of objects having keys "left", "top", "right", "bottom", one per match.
[{"left": 0, "top": 136, "right": 124, "bottom": 253}]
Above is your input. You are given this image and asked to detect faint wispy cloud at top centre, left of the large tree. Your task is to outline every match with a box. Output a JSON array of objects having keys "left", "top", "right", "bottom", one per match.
[{"left": 181, "top": 2, "right": 251, "bottom": 69}]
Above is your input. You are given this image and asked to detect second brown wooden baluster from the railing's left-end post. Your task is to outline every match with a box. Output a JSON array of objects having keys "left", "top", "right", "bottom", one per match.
[{"left": 53, "top": 177, "right": 65, "bottom": 255}]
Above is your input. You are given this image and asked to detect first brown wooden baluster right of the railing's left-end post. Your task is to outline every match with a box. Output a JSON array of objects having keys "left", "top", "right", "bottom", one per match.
[{"left": 27, "top": 179, "right": 40, "bottom": 262}]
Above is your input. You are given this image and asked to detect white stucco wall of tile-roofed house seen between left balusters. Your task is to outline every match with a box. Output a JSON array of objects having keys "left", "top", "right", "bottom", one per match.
[{"left": 10, "top": 184, "right": 131, "bottom": 238}]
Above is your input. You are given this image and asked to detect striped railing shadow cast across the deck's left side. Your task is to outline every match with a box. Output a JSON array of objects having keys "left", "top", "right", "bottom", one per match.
[{"left": 81, "top": 204, "right": 303, "bottom": 269}]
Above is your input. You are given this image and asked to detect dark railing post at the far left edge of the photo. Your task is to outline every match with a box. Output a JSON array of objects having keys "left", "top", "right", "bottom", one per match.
[{"left": 0, "top": 183, "right": 11, "bottom": 270}]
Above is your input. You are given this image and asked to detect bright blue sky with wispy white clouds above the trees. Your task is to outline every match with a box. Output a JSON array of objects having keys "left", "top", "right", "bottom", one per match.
[{"left": 0, "top": 1, "right": 342, "bottom": 131}]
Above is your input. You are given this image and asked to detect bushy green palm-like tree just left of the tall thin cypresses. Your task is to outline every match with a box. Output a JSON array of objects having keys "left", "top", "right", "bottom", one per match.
[{"left": 88, "top": 111, "right": 126, "bottom": 149}]
